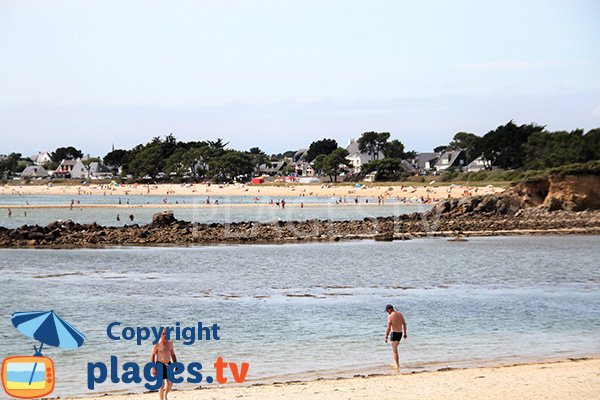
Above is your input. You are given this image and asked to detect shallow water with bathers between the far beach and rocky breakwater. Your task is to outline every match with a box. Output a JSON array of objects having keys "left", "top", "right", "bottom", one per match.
[{"left": 0, "top": 195, "right": 431, "bottom": 228}]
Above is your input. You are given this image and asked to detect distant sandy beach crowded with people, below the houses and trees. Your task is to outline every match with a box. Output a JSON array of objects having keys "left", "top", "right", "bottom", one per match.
[{"left": 0, "top": 183, "right": 504, "bottom": 205}]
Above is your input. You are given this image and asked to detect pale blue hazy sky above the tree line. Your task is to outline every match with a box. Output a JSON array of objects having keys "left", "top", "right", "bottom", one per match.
[{"left": 0, "top": 0, "right": 600, "bottom": 156}]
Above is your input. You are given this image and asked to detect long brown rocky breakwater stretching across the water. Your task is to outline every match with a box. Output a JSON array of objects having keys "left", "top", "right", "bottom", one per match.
[{"left": 0, "top": 206, "right": 600, "bottom": 247}]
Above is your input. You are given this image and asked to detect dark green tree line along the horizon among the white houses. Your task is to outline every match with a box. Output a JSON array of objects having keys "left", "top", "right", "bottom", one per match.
[{"left": 0, "top": 120, "right": 600, "bottom": 182}]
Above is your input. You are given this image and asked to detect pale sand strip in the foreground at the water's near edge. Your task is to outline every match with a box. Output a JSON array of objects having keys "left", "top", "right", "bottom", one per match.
[{"left": 77, "top": 359, "right": 600, "bottom": 400}]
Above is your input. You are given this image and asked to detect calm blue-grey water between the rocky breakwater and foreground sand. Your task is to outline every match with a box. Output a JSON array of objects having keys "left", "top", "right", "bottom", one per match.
[{"left": 0, "top": 236, "right": 600, "bottom": 396}]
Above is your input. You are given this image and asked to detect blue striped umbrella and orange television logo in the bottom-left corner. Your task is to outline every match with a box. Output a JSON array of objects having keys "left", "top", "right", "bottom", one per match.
[{"left": 2, "top": 311, "right": 85, "bottom": 399}]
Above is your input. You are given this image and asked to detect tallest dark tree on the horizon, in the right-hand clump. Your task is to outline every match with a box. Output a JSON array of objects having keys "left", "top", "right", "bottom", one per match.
[{"left": 481, "top": 121, "right": 544, "bottom": 169}]
